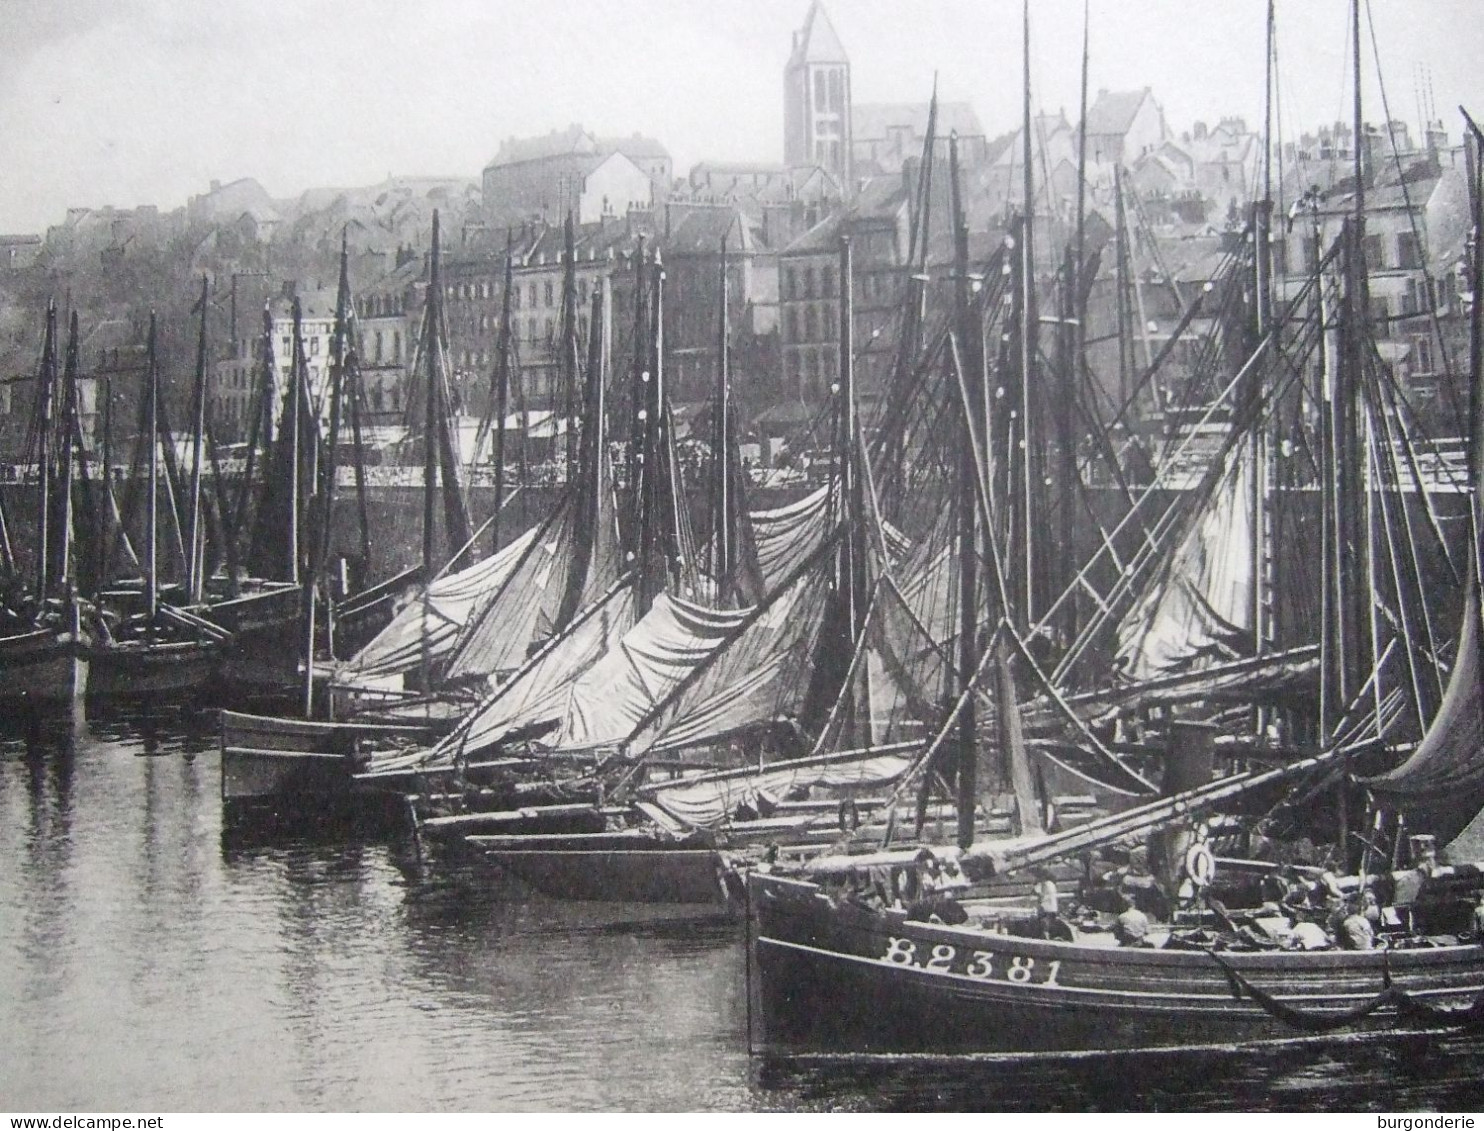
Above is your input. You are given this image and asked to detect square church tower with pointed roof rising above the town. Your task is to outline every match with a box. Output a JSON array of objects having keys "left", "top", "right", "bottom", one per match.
[{"left": 784, "top": 0, "right": 850, "bottom": 186}]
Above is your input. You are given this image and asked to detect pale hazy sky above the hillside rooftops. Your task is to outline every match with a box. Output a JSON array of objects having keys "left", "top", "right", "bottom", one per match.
[{"left": 0, "top": 0, "right": 1484, "bottom": 233}]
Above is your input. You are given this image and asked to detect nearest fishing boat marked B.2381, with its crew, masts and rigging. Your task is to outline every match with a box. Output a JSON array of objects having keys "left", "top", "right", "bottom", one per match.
[{"left": 746, "top": 4, "right": 1484, "bottom": 1055}]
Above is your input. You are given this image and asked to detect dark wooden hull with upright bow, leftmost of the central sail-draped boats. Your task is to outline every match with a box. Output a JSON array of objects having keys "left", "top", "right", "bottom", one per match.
[{"left": 221, "top": 711, "right": 420, "bottom": 812}]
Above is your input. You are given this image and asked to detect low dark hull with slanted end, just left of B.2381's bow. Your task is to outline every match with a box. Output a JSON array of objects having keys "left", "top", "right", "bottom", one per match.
[{"left": 469, "top": 833, "right": 741, "bottom": 904}]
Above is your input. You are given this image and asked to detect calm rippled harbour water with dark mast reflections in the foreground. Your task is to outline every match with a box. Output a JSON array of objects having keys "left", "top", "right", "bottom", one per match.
[{"left": 0, "top": 708, "right": 1484, "bottom": 1112}]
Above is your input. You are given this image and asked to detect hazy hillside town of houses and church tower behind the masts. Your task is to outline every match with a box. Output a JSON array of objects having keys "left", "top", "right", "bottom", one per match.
[{"left": 0, "top": 1, "right": 1468, "bottom": 460}]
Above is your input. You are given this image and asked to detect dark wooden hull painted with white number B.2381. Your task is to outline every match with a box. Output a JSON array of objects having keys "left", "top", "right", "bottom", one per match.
[{"left": 748, "top": 873, "right": 1484, "bottom": 1054}]
